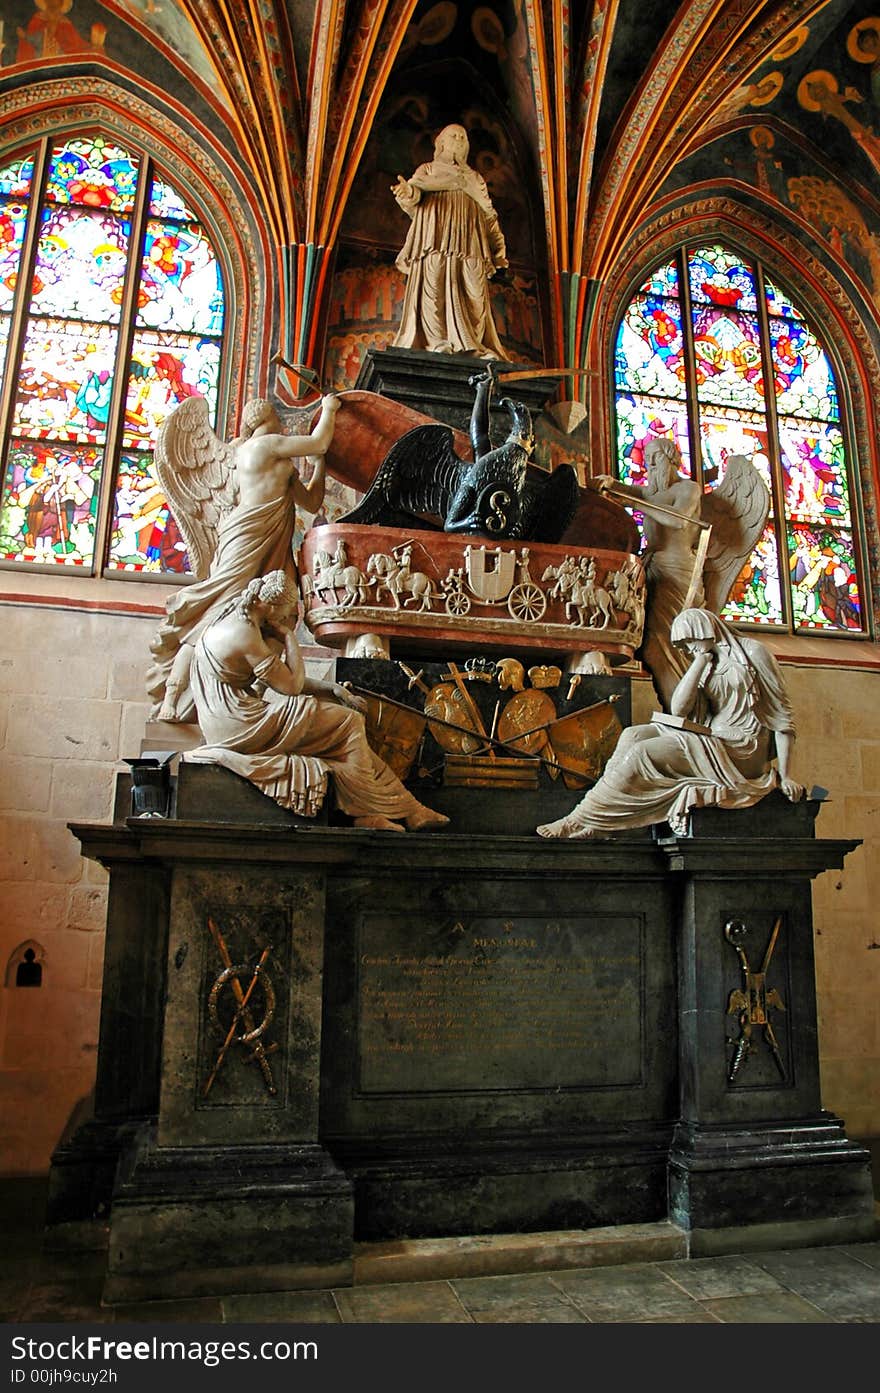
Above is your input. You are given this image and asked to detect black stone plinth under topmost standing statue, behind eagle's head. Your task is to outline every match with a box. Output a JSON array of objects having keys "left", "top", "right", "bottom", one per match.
[{"left": 355, "top": 348, "right": 560, "bottom": 429}]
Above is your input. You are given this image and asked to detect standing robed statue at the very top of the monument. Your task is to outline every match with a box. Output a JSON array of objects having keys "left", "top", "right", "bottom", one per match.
[{"left": 391, "top": 125, "right": 507, "bottom": 361}]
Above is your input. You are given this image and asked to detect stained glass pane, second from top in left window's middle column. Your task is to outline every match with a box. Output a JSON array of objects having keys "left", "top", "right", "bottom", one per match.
[{"left": 31, "top": 205, "right": 131, "bottom": 325}]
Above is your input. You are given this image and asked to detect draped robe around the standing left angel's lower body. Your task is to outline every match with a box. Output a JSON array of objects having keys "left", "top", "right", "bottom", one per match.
[{"left": 146, "top": 486, "right": 297, "bottom": 720}]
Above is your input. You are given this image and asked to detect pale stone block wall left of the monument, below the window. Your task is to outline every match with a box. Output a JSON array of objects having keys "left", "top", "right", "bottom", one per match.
[{"left": 0, "top": 605, "right": 156, "bottom": 1173}]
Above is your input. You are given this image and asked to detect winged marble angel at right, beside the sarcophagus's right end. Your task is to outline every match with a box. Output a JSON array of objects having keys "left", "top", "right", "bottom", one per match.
[{"left": 592, "top": 437, "right": 770, "bottom": 710}]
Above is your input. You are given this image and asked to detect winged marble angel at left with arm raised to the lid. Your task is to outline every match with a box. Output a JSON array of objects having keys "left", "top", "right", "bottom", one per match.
[{"left": 148, "top": 396, "right": 340, "bottom": 722}]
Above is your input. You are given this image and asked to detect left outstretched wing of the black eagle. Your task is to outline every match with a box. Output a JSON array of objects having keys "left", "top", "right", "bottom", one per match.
[{"left": 340, "top": 425, "right": 473, "bottom": 527}]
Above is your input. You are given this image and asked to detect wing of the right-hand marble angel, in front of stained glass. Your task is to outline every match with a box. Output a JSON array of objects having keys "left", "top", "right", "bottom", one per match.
[{"left": 702, "top": 454, "right": 770, "bottom": 614}]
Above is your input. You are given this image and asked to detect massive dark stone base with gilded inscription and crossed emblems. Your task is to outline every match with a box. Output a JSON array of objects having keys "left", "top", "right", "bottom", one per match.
[{"left": 50, "top": 765, "right": 874, "bottom": 1301}]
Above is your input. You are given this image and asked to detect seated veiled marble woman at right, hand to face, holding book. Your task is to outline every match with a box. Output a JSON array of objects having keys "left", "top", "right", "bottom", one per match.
[{"left": 537, "top": 609, "right": 803, "bottom": 840}]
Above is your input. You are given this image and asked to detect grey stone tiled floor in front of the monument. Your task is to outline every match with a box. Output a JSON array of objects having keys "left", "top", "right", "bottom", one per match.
[{"left": 0, "top": 1175, "right": 880, "bottom": 1325}]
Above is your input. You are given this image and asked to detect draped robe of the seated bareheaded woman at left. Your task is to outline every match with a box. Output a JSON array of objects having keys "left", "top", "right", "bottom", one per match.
[{"left": 184, "top": 630, "right": 422, "bottom": 819}]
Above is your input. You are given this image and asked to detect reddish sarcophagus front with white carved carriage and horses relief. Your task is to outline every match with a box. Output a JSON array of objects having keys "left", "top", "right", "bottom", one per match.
[{"left": 299, "top": 522, "right": 645, "bottom": 660}]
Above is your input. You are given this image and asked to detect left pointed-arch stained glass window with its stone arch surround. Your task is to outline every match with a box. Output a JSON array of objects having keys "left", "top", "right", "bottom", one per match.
[{"left": 0, "top": 81, "right": 265, "bottom": 577}]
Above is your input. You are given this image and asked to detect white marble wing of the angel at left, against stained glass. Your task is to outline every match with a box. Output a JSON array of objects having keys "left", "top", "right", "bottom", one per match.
[{"left": 155, "top": 397, "right": 237, "bottom": 581}]
